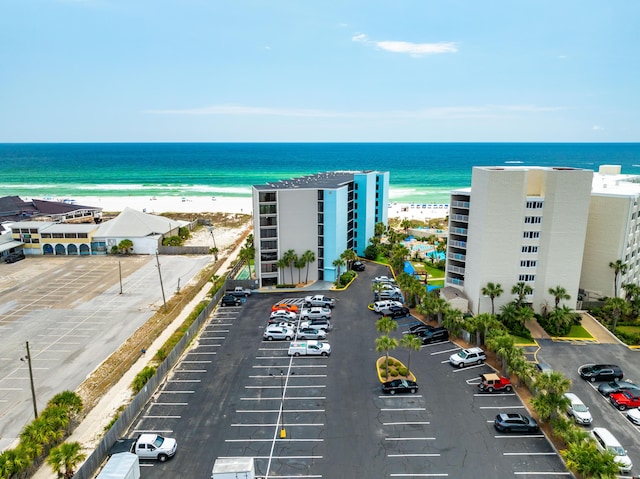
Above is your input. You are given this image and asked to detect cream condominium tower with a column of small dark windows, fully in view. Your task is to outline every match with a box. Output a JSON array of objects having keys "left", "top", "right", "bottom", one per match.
[{"left": 445, "top": 167, "right": 593, "bottom": 314}]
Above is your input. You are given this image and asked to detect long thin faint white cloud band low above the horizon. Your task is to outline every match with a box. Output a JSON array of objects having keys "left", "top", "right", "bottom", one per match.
[{"left": 146, "top": 105, "right": 564, "bottom": 118}]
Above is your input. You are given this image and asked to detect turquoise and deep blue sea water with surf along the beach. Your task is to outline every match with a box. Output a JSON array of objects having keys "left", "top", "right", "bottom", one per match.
[{"left": 0, "top": 143, "right": 640, "bottom": 203}]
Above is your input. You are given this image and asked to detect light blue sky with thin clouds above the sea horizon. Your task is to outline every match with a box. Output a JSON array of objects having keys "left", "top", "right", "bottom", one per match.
[{"left": 0, "top": 0, "right": 640, "bottom": 142}]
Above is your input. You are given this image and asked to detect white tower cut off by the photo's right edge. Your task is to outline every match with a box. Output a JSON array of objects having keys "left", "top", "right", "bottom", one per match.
[{"left": 579, "top": 165, "right": 640, "bottom": 301}]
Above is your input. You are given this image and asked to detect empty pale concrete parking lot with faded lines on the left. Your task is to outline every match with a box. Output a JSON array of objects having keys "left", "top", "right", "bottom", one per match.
[{"left": 0, "top": 256, "right": 214, "bottom": 450}]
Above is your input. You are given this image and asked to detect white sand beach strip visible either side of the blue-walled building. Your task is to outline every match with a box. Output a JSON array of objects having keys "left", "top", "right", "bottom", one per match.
[{"left": 26, "top": 196, "right": 449, "bottom": 221}]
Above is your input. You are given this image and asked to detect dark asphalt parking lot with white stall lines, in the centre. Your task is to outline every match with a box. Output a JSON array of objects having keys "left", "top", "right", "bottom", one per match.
[{"left": 130, "top": 266, "right": 570, "bottom": 478}]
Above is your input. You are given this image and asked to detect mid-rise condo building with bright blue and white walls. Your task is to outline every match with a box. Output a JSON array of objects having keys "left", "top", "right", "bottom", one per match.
[{"left": 252, "top": 171, "right": 389, "bottom": 287}]
